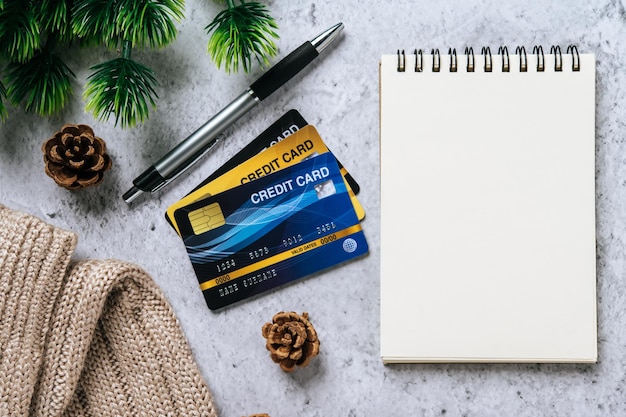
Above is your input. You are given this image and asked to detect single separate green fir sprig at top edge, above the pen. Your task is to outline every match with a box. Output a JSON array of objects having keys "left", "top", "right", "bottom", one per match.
[{"left": 205, "top": 0, "right": 278, "bottom": 72}]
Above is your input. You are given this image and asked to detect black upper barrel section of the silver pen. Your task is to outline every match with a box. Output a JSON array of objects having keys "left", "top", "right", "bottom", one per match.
[{"left": 250, "top": 42, "right": 319, "bottom": 100}]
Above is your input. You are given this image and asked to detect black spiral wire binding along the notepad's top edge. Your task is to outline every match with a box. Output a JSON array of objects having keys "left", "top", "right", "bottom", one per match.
[{"left": 397, "top": 45, "right": 580, "bottom": 72}]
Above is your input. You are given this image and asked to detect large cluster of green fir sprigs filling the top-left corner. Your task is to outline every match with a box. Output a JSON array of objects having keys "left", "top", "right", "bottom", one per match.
[{"left": 0, "top": 0, "right": 184, "bottom": 127}]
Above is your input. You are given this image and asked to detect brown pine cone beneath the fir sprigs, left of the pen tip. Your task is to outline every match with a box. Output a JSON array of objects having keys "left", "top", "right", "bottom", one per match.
[{"left": 41, "top": 124, "right": 111, "bottom": 190}]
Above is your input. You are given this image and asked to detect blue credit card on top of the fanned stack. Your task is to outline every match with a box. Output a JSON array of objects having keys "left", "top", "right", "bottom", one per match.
[{"left": 174, "top": 153, "right": 368, "bottom": 310}]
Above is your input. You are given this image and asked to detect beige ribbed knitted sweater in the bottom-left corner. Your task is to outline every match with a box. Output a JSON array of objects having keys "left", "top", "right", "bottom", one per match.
[{"left": 0, "top": 205, "right": 216, "bottom": 417}]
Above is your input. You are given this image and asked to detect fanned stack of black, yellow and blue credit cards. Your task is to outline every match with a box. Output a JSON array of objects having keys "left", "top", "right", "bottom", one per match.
[{"left": 165, "top": 110, "right": 368, "bottom": 310}]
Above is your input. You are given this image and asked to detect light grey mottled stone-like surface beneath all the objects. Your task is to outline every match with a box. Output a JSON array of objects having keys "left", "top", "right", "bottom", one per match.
[{"left": 0, "top": 0, "right": 626, "bottom": 417}]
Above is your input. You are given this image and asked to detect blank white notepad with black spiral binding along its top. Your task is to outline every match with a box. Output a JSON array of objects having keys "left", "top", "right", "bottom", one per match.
[{"left": 380, "top": 47, "right": 597, "bottom": 363}]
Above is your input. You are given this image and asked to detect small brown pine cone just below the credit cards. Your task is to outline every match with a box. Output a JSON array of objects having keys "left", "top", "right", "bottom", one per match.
[{"left": 261, "top": 311, "right": 320, "bottom": 372}]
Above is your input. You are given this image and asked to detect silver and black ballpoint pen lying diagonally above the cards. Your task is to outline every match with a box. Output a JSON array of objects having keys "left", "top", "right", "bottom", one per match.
[{"left": 123, "top": 23, "right": 343, "bottom": 203}]
